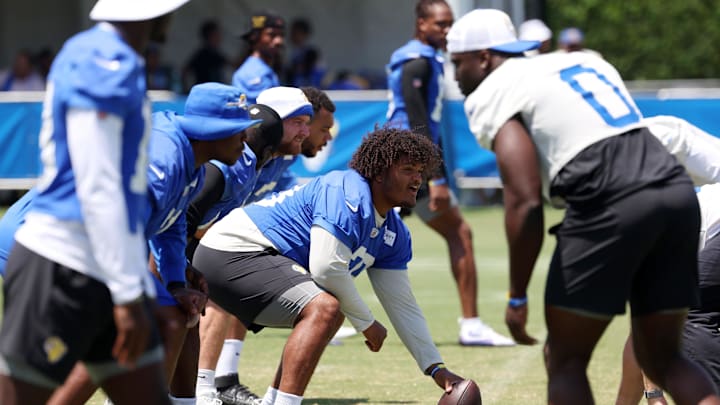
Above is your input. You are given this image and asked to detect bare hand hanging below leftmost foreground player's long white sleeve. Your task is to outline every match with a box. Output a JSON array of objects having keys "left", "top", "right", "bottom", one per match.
[{"left": 112, "top": 297, "right": 151, "bottom": 367}]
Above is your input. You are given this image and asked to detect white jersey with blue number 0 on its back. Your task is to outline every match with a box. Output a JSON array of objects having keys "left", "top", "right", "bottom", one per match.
[{"left": 465, "top": 52, "right": 644, "bottom": 198}]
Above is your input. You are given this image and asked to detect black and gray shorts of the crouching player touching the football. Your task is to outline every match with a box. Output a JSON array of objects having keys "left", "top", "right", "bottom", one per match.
[{"left": 193, "top": 245, "right": 322, "bottom": 333}]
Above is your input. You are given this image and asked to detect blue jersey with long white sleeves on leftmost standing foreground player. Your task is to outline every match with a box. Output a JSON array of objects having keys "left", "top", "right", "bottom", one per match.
[{"left": 15, "top": 23, "right": 154, "bottom": 304}]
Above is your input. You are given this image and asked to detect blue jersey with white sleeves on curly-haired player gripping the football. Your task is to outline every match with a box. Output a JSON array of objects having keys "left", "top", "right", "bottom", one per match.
[{"left": 196, "top": 170, "right": 442, "bottom": 370}]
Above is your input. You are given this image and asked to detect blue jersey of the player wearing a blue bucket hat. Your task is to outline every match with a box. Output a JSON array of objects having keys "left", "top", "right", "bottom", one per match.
[{"left": 146, "top": 111, "right": 205, "bottom": 285}]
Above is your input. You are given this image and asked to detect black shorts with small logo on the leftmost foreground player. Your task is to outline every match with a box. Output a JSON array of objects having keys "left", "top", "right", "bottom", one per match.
[{"left": 0, "top": 243, "right": 160, "bottom": 385}]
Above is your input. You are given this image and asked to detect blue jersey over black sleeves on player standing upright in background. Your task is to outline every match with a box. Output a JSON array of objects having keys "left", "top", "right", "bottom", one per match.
[{"left": 386, "top": 39, "right": 443, "bottom": 144}]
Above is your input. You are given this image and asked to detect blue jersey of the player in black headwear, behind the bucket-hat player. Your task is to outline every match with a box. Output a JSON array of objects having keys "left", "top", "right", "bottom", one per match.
[{"left": 199, "top": 144, "right": 258, "bottom": 228}]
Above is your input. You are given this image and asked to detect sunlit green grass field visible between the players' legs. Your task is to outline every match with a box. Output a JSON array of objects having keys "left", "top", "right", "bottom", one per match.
[{"left": 1, "top": 207, "right": 640, "bottom": 405}]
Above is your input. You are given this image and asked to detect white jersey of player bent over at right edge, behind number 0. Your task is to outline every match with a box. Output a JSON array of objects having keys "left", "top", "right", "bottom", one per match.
[{"left": 645, "top": 115, "right": 720, "bottom": 186}]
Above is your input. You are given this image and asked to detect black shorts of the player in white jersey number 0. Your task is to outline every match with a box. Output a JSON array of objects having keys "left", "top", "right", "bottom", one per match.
[{"left": 545, "top": 183, "right": 700, "bottom": 316}]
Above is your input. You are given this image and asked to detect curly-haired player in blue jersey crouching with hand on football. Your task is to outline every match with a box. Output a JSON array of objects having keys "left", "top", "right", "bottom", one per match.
[{"left": 193, "top": 128, "right": 462, "bottom": 404}]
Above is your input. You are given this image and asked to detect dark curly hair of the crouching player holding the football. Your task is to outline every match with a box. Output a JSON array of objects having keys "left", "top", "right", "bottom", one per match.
[{"left": 349, "top": 125, "right": 442, "bottom": 179}]
